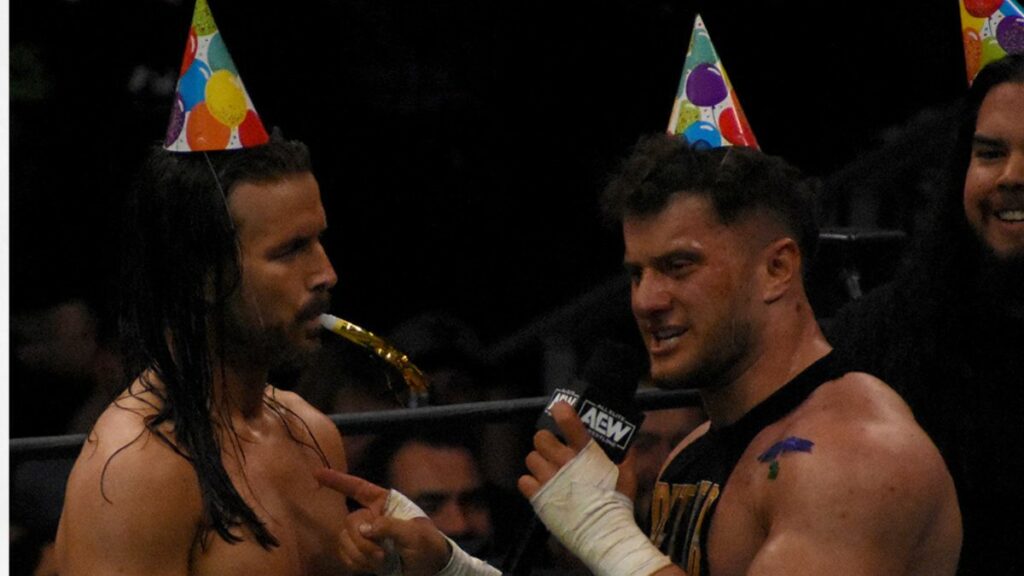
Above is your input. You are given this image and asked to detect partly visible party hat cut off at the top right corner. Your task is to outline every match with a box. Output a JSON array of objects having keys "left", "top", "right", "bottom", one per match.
[{"left": 959, "top": 0, "right": 1024, "bottom": 84}]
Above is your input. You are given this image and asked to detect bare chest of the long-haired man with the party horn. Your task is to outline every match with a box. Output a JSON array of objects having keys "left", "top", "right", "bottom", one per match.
[{"left": 189, "top": 436, "right": 346, "bottom": 576}]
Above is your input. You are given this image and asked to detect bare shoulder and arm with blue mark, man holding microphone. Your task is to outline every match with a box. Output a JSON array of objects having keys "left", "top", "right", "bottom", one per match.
[{"left": 746, "top": 372, "right": 961, "bottom": 574}]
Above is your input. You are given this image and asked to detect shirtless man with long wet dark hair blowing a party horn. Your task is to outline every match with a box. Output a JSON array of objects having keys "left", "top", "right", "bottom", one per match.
[{"left": 56, "top": 138, "right": 345, "bottom": 576}]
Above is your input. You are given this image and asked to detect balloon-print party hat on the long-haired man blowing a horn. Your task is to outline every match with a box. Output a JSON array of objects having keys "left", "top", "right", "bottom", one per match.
[{"left": 164, "top": 0, "right": 270, "bottom": 152}]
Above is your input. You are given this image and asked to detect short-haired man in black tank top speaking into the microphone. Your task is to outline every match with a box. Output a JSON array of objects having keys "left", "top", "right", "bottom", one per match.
[{"left": 318, "top": 135, "right": 962, "bottom": 576}]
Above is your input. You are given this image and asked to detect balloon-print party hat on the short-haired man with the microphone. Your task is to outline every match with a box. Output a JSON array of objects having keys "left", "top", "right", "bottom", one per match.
[{"left": 669, "top": 14, "right": 759, "bottom": 149}]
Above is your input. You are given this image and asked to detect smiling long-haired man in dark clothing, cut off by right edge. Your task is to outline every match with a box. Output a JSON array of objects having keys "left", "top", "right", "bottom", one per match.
[{"left": 828, "top": 51, "right": 1024, "bottom": 574}]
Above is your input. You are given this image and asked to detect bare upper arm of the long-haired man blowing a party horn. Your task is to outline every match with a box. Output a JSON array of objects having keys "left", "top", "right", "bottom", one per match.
[{"left": 57, "top": 420, "right": 203, "bottom": 576}]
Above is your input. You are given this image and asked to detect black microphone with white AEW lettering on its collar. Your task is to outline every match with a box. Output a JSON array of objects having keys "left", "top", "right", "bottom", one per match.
[{"left": 502, "top": 340, "right": 646, "bottom": 576}]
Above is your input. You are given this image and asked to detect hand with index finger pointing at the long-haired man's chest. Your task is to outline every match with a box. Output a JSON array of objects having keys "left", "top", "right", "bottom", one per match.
[{"left": 314, "top": 468, "right": 450, "bottom": 576}]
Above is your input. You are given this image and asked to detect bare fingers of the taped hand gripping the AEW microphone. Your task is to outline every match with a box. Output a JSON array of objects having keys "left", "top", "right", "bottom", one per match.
[{"left": 517, "top": 402, "right": 637, "bottom": 500}]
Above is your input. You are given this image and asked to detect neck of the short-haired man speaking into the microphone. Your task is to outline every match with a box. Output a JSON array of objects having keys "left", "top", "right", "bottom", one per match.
[{"left": 700, "top": 301, "right": 831, "bottom": 427}]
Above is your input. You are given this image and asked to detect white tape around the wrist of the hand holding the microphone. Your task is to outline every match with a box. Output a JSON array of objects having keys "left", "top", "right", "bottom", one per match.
[{"left": 529, "top": 440, "right": 672, "bottom": 576}]
